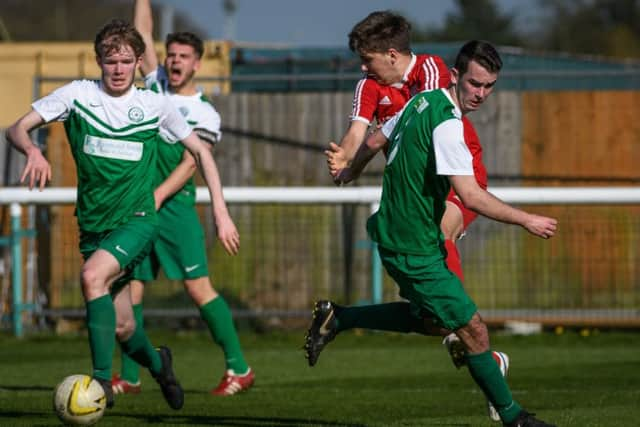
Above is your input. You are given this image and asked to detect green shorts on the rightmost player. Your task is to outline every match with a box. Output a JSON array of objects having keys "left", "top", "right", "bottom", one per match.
[{"left": 378, "top": 248, "right": 478, "bottom": 330}]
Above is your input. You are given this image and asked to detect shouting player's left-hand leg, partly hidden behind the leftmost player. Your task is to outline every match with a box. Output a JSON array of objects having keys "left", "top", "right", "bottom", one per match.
[{"left": 111, "top": 280, "right": 144, "bottom": 394}]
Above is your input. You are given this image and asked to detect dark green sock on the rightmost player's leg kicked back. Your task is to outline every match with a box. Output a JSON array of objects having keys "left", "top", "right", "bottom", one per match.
[{"left": 336, "top": 302, "right": 426, "bottom": 334}]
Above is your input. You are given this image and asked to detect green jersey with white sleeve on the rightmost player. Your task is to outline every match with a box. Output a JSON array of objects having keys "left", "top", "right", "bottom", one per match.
[{"left": 367, "top": 89, "right": 473, "bottom": 256}]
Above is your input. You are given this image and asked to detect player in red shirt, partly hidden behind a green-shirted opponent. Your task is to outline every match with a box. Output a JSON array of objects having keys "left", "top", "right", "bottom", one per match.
[{"left": 329, "top": 11, "right": 509, "bottom": 421}]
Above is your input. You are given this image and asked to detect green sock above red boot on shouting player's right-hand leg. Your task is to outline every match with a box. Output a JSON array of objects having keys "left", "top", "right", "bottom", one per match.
[{"left": 200, "top": 295, "right": 249, "bottom": 374}]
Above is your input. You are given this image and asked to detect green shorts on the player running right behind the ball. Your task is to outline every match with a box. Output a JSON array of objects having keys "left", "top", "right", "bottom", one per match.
[{"left": 80, "top": 215, "right": 158, "bottom": 293}]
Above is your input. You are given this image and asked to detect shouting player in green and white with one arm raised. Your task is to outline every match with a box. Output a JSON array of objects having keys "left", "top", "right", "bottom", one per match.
[{"left": 113, "top": 0, "right": 254, "bottom": 396}]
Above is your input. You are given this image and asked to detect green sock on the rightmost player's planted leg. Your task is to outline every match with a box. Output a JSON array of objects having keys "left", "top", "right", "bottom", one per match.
[{"left": 466, "top": 351, "right": 522, "bottom": 423}]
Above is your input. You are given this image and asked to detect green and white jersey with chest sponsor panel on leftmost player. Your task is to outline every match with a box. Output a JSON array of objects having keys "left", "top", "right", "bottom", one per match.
[{"left": 32, "top": 80, "right": 191, "bottom": 232}]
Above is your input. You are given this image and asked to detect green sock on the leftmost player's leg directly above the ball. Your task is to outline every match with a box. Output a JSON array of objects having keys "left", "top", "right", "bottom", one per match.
[{"left": 86, "top": 295, "right": 116, "bottom": 381}]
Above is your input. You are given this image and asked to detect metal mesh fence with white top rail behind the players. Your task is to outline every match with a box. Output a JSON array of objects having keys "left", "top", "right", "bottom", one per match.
[{"left": 0, "top": 187, "right": 640, "bottom": 338}]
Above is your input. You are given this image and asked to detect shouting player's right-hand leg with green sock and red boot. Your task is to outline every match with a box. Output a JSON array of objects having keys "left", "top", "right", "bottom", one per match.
[{"left": 184, "top": 276, "right": 254, "bottom": 396}]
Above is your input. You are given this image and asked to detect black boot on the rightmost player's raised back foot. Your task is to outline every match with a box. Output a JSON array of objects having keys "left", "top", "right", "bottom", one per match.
[{"left": 304, "top": 301, "right": 338, "bottom": 366}]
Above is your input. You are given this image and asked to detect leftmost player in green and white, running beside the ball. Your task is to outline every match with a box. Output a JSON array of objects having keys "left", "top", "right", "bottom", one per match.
[{"left": 7, "top": 19, "right": 230, "bottom": 409}]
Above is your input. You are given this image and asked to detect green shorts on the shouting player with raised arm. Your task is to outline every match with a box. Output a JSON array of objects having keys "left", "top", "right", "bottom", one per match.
[{"left": 133, "top": 200, "right": 209, "bottom": 281}]
